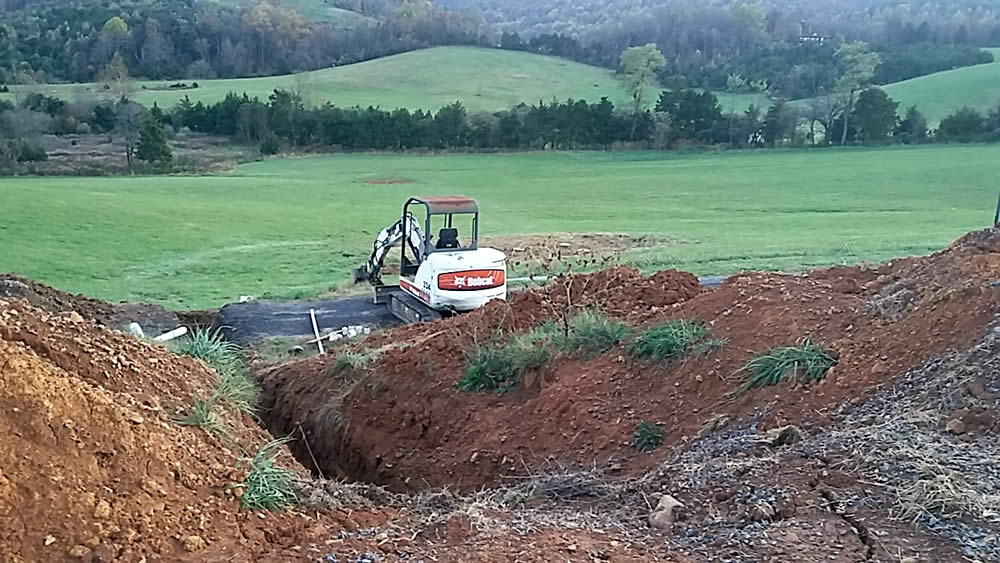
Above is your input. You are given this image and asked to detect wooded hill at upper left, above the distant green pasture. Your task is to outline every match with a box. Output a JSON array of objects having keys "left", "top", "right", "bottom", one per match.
[{"left": 0, "top": 0, "right": 485, "bottom": 84}]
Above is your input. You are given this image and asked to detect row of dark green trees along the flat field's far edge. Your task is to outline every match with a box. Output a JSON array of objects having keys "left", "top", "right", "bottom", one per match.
[{"left": 7, "top": 80, "right": 1000, "bottom": 174}]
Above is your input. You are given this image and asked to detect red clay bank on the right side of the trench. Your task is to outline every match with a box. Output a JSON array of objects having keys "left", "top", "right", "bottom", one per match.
[{"left": 264, "top": 230, "right": 1000, "bottom": 490}]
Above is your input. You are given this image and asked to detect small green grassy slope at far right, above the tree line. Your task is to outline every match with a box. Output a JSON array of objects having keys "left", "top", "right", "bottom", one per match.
[{"left": 883, "top": 48, "right": 1000, "bottom": 124}]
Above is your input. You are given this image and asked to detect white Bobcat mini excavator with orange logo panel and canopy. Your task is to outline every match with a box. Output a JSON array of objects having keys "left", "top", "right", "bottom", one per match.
[{"left": 354, "top": 196, "right": 507, "bottom": 323}]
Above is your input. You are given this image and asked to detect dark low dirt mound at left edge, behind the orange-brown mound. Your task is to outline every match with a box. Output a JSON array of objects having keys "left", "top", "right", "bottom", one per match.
[{"left": 0, "top": 274, "right": 181, "bottom": 336}]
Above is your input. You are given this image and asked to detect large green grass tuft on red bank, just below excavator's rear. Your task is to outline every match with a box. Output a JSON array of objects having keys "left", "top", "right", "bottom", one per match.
[{"left": 458, "top": 325, "right": 551, "bottom": 393}]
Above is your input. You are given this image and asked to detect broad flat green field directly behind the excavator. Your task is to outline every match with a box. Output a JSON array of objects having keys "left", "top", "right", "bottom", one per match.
[{"left": 0, "top": 146, "right": 1000, "bottom": 308}]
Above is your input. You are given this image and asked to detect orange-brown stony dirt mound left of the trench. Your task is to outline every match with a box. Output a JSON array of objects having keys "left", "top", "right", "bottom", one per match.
[{"left": 0, "top": 300, "right": 338, "bottom": 561}]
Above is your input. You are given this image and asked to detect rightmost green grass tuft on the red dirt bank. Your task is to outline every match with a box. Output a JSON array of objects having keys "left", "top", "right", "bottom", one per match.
[{"left": 729, "top": 338, "right": 837, "bottom": 396}]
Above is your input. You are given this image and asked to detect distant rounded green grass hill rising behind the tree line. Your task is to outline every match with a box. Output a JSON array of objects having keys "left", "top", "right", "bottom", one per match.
[{"left": 0, "top": 47, "right": 760, "bottom": 111}]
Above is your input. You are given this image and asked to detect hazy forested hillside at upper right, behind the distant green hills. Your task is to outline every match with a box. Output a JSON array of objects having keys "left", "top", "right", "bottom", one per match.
[{"left": 438, "top": 0, "right": 1000, "bottom": 99}]
